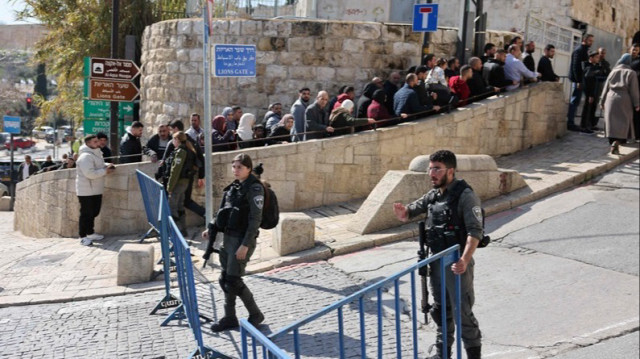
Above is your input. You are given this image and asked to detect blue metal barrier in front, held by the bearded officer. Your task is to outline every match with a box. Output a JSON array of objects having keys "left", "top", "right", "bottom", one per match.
[{"left": 241, "top": 245, "right": 462, "bottom": 359}]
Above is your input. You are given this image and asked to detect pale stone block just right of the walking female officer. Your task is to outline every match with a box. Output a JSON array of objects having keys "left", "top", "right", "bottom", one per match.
[{"left": 271, "top": 213, "right": 316, "bottom": 256}]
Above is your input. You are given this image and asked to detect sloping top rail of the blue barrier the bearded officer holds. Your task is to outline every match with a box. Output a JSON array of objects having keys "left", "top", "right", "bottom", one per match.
[{"left": 268, "top": 244, "right": 460, "bottom": 340}]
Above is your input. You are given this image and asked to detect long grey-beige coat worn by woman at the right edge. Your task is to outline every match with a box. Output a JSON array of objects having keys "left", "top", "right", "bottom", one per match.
[{"left": 600, "top": 65, "right": 640, "bottom": 139}]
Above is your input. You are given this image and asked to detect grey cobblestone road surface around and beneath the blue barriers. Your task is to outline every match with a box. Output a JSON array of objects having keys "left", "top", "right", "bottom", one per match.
[{"left": 0, "top": 262, "right": 430, "bottom": 358}]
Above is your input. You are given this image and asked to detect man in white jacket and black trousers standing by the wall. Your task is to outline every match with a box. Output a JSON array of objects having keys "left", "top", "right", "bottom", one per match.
[{"left": 76, "top": 135, "right": 115, "bottom": 246}]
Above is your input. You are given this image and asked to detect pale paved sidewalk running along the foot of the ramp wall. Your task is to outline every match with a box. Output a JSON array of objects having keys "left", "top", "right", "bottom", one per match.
[{"left": 0, "top": 133, "right": 640, "bottom": 307}]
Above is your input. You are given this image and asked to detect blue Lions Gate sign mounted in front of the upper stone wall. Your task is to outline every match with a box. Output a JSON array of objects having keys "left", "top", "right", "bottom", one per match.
[{"left": 213, "top": 45, "right": 256, "bottom": 77}]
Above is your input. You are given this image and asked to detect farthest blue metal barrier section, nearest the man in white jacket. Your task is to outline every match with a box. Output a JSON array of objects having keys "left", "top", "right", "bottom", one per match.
[{"left": 136, "top": 170, "right": 180, "bottom": 314}]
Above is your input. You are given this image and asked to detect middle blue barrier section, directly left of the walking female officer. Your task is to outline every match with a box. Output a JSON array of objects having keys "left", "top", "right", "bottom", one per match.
[{"left": 160, "top": 216, "right": 229, "bottom": 359}]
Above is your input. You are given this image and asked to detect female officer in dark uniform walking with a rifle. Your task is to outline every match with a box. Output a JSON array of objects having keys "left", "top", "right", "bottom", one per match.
[{"left": 202, "top": 153, "right": 264, "bottom": 332}]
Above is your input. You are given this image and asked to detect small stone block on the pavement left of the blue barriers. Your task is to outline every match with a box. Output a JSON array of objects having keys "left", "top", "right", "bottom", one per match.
[{"left": 117, "top": 243, "right": 154, "bottom": 285}]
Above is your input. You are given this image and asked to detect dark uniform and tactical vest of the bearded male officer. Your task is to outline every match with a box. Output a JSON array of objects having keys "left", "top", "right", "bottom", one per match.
[{"left": 407, "top": 180, "right": 483, "bottom": 358}]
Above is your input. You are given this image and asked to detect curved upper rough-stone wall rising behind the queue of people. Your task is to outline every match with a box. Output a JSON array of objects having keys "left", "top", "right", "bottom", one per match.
[{"left": 140, "top": 19, "right": 421, "bottom": 137}]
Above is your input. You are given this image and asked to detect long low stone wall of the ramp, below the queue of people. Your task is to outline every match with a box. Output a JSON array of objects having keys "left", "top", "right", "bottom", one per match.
[{"left": 14, "top": 83, "right": 566, "bottom": 237}]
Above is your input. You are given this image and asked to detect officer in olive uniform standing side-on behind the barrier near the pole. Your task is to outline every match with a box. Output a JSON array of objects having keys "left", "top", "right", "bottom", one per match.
[{"left": 167, "top": 131, "right": 198, "bottom": 237}]
